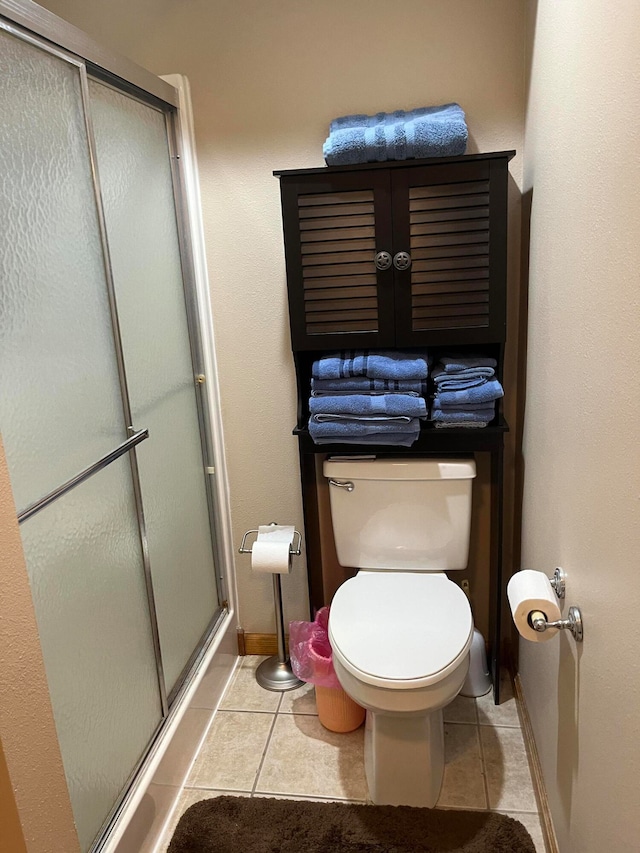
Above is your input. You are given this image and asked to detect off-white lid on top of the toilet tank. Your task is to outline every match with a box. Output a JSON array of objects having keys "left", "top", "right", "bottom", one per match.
[{"left": 322, "top": 456, "right": 476, "bottom": 480}]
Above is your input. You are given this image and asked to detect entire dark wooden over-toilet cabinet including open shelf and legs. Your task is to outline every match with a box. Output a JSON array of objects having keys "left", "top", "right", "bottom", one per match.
[{"left": 274, "top": 151, "right": 515, "bottom": 702}]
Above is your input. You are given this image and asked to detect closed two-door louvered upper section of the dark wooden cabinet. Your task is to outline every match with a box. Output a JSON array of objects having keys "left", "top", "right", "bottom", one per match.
[{"left": 275, "top": 151, "right": 514, "bottom": 351}]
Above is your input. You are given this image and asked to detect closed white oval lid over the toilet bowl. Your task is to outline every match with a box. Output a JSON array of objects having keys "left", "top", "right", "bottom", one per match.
[{"left": 329, "top": 571, "right": 473, "bottom": 688}]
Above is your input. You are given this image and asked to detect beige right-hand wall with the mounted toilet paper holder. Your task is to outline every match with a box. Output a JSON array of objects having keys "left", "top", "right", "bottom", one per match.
[{"left": 520, "top": 0, "right": 640, "bottom": 853}]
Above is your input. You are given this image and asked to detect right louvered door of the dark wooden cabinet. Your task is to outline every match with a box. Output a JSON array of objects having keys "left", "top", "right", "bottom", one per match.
[{"left": 392, "top": 158, "right": 507, "bottom": 346}]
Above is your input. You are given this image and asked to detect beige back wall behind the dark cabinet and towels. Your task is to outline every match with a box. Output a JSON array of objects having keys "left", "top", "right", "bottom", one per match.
[{"left": 44, "top": 0, "right": 524, "bottom": 632}]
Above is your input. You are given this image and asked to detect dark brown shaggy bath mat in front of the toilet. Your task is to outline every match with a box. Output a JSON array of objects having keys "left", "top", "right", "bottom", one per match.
[{"left": 168, "top": 797, "right": 535, "bottom": 853}]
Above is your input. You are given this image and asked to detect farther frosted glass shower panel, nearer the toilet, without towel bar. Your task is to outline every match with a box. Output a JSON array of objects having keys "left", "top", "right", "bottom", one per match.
[{"left": 89, "top": 80, "right": 219, "bottom": 694}]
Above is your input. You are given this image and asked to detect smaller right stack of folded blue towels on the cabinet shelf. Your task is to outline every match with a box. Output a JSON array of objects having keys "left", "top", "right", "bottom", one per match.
[{"left": 431, "top": 356, "right": 504, "bottom": 428}]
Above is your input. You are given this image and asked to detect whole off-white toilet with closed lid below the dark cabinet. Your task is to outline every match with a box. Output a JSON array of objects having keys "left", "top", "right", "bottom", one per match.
[{"left": 323, "top": 457, "right": 476, "bottom": 808}]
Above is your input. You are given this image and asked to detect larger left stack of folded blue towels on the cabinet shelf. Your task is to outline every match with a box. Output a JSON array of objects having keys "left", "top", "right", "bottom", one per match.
[{"left": 309, "top": 350, "right": 429, "bottom": 447}]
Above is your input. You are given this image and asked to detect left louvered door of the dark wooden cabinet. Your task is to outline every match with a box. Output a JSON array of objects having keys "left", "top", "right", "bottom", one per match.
[{"left": 281, "top": 170, "right": 395, "bottom": 350}]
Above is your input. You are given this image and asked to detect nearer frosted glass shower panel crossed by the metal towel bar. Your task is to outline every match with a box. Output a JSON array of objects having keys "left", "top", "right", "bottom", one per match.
[{"left": 0, "top": 27, "right": 161, "bottom": 850}]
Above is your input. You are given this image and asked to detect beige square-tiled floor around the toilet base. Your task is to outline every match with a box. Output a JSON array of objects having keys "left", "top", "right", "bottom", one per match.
[{"left": 158, "top": 656, "right": 545, "bottom": 853}]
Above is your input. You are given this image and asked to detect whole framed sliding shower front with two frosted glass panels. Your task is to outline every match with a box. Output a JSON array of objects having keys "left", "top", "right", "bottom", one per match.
[{"left": 0, "top": 3, "right": 227, "bottom": 851}]
